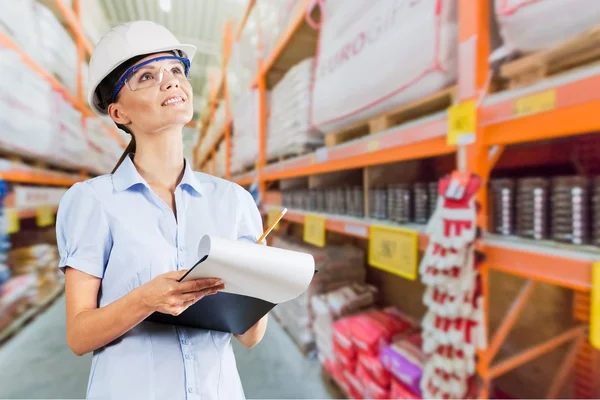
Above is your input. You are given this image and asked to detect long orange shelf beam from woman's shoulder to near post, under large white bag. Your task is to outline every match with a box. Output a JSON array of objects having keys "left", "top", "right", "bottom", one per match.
[{"left": 262, "top": 113, "right": 456, "bottom": 181}]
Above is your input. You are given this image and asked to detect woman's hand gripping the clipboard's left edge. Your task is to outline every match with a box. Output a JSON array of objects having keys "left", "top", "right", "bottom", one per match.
[{"left": 140, "top": 271, "right": 225, "bottom": 316}]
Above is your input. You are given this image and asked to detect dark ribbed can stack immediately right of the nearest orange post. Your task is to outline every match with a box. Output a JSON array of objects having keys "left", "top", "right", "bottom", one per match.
[{"left": 491, "top": 179, "right": 515, "bottom": 236}]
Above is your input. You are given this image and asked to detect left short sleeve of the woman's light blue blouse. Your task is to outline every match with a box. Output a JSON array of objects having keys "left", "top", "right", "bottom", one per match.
[{"left": 56, "top": 182, "right": 112, "bottom": 278}]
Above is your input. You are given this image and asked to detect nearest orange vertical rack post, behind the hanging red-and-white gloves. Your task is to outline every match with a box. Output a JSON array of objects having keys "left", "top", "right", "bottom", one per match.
[{"left": 457, "top": 0, "right": 491, "bottom": 398}]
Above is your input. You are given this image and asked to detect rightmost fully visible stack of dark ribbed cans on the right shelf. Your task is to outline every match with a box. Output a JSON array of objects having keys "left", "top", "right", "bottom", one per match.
[{"left": 551, "top": 176, "right": 590, "bottom": 245}]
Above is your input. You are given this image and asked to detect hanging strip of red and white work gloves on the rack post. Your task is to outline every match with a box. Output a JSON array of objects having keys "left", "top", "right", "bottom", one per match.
[{"left": 419, "top": 173, "right": 487, "bottom": 399}]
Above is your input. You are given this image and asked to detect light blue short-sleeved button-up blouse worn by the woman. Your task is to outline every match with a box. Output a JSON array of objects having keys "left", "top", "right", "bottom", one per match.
[{"left": 56, "top": 157, "right": 262, "bottom": 400}]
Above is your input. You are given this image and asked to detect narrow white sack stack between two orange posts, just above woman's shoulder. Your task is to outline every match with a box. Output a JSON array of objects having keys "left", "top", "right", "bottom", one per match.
[{"left": 231, "top": 89, "right": 259, "bottom": 173}]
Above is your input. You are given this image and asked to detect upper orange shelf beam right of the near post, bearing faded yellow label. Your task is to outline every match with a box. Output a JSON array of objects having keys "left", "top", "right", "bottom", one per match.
[{"left": 480, "top": 66, "right": 600, "bottom": 145}]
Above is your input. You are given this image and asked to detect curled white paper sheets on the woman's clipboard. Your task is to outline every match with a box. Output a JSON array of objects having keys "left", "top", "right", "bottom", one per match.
[{"left": 183, "top": 235, "right": 315, "bottom": 304}]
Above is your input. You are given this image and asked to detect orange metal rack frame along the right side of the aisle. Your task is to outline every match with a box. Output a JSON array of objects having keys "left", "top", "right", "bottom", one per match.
[{"left": 198, "top": 0, "right": 600, "bottom": 398}]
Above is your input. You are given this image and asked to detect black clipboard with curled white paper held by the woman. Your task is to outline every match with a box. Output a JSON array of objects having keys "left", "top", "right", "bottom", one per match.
[{"left": 146, "top": 231, "right": 316, "bottom": 335}]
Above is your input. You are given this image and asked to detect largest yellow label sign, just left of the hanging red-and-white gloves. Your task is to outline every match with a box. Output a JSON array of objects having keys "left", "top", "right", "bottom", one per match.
[{"left": 369, "top": 225, "right": 419, "bottom": 280}]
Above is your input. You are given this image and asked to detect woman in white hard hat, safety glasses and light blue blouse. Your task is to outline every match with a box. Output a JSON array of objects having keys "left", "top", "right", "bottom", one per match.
[{"left": 56, "top": 21, "right": 267, "bottom": 400}]
